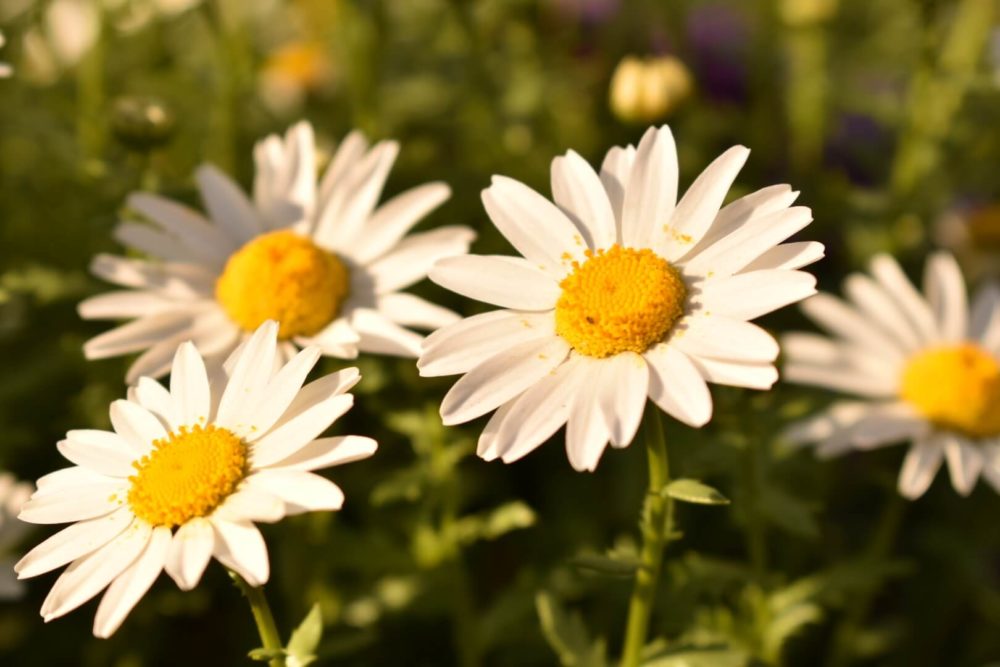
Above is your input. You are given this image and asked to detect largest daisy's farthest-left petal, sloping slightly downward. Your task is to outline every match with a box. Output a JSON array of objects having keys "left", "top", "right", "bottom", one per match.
[{"left": 417, "top": 310, "right": 555, "bottom": 377}]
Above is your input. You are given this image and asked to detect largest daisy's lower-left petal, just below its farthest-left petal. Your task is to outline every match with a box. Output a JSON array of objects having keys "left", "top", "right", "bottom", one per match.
[{"left": 441, "top": 337, "right": 569, "bottom": 426}]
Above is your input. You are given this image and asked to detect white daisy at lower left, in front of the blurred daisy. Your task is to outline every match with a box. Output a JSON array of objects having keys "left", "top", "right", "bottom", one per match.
[{"left": 15, "top": 322, "right": 376, "bottom": 637}]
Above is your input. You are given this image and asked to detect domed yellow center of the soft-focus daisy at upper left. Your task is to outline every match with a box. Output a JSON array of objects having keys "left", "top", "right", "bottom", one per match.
[{"left": 215, "top": 231, "right": 350, "bottom": 339}]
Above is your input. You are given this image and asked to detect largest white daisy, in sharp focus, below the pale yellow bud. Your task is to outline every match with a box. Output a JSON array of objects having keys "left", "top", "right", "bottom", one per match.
[{"left": 418, "top": 126, "right": 823, "bottom": 470}]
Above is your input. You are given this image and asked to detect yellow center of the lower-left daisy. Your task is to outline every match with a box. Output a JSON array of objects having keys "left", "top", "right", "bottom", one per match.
[{"left": 128, "top": 425, "right": 247, "bottom": 527}]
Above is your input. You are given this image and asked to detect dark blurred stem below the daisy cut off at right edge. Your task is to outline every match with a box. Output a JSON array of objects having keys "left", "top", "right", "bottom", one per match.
[{"left": 826, "top": 489, "right": 908, "bottom": 667}]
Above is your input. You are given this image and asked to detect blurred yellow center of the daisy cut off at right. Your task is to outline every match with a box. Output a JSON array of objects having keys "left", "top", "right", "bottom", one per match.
[{"left": 900, "top": 343, "right": 1000, "bottom": 437}]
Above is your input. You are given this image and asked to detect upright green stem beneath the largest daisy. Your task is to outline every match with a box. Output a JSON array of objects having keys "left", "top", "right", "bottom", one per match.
[{"left": 621, "top": 408, "right": 674, "bottom": 667}]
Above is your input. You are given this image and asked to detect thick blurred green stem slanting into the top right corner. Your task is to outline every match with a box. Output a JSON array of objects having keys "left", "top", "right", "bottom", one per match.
[{"left": 891, "top": 0, "right": 995, "bottom": 200}]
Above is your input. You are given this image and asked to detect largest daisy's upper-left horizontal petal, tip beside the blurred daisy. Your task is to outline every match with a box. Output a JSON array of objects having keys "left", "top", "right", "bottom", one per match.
[{"left": 430, "top": 255, "right": 562, "bottom": 311}]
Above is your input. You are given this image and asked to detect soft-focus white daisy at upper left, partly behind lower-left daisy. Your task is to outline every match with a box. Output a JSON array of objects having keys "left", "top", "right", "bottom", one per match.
[{"left": 80, "top": 123, "right": 474, "bottom": 382}]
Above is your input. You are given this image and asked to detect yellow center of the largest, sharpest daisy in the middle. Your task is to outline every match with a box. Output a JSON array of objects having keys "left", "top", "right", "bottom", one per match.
[{"left": 556, "top": 244, "right": 687, "bottom": 358}]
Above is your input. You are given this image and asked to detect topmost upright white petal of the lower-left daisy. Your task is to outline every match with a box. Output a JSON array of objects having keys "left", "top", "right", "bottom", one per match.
[{"left": 215, "top": 320, "right": 278, "bottom": 428}]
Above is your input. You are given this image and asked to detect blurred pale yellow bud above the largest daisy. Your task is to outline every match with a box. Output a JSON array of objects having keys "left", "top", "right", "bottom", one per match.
[{"left": 610, "top": 56, "right": 692, "bottom": 123}]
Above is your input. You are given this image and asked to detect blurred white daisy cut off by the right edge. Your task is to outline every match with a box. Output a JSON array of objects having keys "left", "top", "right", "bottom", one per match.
[{"left": 782, "top": 253, "right": 1000, "bottom": 499}]
